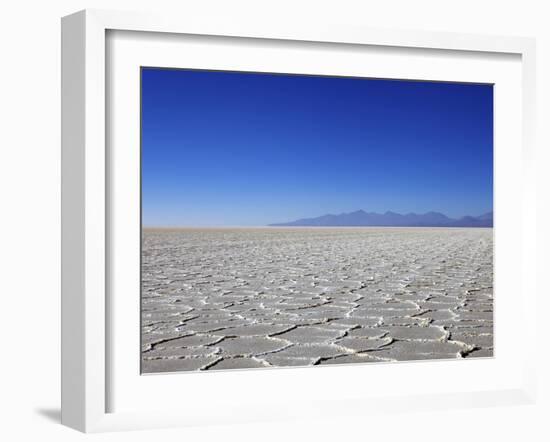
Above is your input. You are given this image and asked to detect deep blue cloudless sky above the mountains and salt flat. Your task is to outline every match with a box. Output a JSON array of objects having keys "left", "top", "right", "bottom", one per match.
[{"left": 142, "top": 68, "right": 493, "bottom": 226}]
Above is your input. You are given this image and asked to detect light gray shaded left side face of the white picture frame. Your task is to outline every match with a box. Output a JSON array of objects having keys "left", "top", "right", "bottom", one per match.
[{"left": 61, "top": 11, "right": 86, "bottom": 431}]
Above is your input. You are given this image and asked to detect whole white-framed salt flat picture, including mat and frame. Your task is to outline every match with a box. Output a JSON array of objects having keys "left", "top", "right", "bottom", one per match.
[{"left": 62, "top": 11, "right": 536, "bottom": 432}]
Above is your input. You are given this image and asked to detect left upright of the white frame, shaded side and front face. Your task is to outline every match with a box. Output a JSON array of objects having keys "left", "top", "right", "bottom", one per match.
[{"left": 61, "top": 11, "right": 107, "bottom": 432}]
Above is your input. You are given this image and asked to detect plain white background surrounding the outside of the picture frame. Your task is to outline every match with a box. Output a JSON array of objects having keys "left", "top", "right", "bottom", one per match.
[{"left": 0, "top": 0, "right": 550, "bottom": 441}]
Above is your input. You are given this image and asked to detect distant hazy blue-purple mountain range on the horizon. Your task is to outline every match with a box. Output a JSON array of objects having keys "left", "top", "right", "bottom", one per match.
[{"left": 269, "top": 210, "right": 493, "bottom": 227}]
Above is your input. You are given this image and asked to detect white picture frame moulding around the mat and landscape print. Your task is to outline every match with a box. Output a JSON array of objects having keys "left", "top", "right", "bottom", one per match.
[{"left": 62, "top": 10, "right": 536, "bottom": 432}]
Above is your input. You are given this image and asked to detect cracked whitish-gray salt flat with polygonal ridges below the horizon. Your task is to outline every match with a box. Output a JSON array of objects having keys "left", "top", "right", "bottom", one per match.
[{"left": 142, "top": 227, "right": 493, "bottom": 373}]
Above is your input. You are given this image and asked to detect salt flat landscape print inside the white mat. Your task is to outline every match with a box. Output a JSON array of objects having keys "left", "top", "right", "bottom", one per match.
[{"left": 141, "top": 67, "right": 494, "bottom": 373}]
